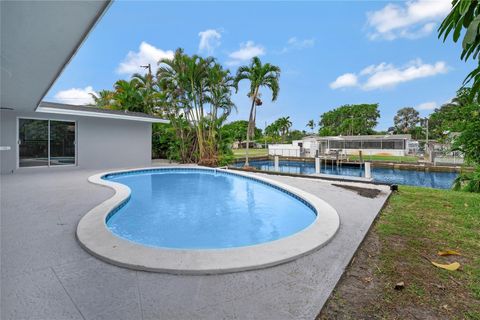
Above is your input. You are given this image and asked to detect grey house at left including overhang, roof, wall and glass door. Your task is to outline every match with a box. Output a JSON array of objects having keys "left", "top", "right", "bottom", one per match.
[{"left": 0, "top": 1, "right": 167, "bottom": 174}]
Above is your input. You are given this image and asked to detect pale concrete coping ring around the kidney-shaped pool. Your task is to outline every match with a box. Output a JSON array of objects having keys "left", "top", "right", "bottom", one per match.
[{"left": 76, "top": 166, "right": 340, "bottom": 275}]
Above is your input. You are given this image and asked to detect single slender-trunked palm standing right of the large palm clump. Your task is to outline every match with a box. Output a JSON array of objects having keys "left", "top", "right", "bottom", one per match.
[{"left": 234, "top": 57, "right": 280, "bottom": 167}]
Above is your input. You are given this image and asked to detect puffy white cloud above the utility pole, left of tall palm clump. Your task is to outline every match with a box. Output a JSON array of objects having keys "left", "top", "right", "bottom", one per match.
[{"left": 117, "top": 41, "right": 174, "bottom": 75}]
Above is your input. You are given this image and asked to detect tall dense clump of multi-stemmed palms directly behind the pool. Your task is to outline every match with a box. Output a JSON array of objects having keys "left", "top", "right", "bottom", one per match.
[{"left": 157, "top": 49, "right": 235, "bottom": 165}]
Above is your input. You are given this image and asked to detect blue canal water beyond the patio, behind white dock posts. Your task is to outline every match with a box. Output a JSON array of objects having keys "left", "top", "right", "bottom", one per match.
[{"left": 236, "top": 160, "right": 457, "bottom": 189}]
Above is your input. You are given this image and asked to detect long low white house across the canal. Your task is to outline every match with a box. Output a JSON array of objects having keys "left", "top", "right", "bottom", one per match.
[{"left": 268, "top": 134, "right": 411, "bottom": 157}]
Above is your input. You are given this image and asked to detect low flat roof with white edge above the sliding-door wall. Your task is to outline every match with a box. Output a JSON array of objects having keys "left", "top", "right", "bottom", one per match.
[{"left": 36, "top": 101, "right": 170, "bottom": 123}]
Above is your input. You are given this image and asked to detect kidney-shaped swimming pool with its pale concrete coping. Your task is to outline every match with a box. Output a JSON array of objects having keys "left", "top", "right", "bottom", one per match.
[{"left": 76, "top": 167, "right": 340, "bottom": 274}]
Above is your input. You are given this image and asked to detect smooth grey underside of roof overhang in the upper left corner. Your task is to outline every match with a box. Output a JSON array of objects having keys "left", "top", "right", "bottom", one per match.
[{"left": 0, "top": 0, "right": 110, "bottom": 111}]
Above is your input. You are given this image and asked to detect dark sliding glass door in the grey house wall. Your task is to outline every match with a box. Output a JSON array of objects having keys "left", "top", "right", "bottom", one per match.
[{"left": 18, "top": 119, "right": 76, "bottom": 167}]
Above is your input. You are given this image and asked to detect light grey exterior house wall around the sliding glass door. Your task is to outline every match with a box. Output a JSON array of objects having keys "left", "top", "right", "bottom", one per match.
[{"left": 0, "top": 110, "right": 152, "bottom": 173}]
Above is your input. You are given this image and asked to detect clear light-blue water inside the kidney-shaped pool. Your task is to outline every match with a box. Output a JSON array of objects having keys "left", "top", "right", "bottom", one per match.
[{"left": 104, "top": 169, "right": 316, "bottom": 249}]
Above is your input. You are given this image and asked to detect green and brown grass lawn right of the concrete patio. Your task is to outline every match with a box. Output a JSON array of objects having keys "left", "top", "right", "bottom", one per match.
[{"left": 319, "top": 186, "right": 480, "bottom": 319}]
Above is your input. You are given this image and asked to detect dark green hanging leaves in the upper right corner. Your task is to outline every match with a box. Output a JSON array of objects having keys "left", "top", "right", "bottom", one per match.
[{"left": 438, "top": 0, "right": 480, "bottom": 94}]
